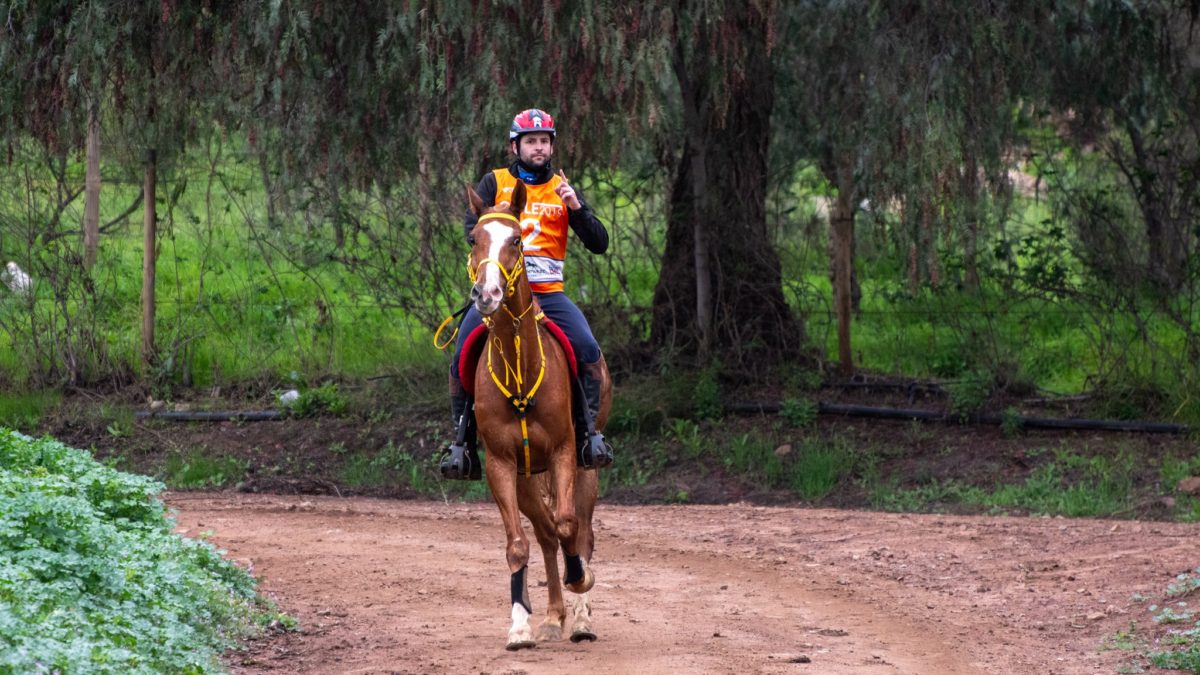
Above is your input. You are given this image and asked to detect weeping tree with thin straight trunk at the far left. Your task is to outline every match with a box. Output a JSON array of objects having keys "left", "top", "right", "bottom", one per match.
[{"left": 0, "top": 0, "right": 238, "bottom": 375}]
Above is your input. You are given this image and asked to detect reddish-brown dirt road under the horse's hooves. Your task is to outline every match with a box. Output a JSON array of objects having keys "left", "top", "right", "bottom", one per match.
[{"left": 166, "top": 494, "right": 1200, "bottom": 675}]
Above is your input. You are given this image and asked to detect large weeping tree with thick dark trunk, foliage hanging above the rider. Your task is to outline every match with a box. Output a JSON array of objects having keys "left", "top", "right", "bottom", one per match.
[{"left": 241, "top": 0, "right": 802, "bottom": 360}]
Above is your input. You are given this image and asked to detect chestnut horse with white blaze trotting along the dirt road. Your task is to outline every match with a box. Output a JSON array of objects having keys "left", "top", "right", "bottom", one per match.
[{"left": 462, "top": 181, "right": 612, "bottom": 650}]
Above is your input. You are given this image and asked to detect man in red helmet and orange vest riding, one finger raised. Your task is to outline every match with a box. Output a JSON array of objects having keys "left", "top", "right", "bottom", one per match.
[{"left": 440, "top": 108, "right": 613, "bottom": 480}]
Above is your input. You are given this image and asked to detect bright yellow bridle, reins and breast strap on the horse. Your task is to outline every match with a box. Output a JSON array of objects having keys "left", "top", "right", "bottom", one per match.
[{"left": 433, "top": 214, "right": 546, "bottom": 478}]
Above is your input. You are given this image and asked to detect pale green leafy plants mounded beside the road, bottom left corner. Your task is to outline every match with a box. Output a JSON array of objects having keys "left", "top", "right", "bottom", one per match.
[{"left": 0, "top": 429, "right": 274, "bottom": 673}]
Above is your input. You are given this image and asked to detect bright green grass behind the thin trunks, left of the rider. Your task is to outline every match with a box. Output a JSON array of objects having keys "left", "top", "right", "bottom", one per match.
[{"left": 0, "top": 147, "right": 457, "bottom": 386}]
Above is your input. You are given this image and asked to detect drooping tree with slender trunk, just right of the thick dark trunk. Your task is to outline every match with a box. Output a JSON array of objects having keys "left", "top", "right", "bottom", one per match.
[{"left": 774, "top": 0, "right": 1044, "bottom": 375}]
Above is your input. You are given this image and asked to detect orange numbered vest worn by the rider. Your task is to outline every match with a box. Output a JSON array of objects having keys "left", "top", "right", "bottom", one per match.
[{"left": 492, "top": 168, "right": 569, "bottom": 293}]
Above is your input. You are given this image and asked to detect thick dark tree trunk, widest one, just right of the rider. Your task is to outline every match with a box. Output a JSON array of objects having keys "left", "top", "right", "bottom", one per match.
[{"left": 650, "top": 4, "right": 804, "bottom": 365}]
